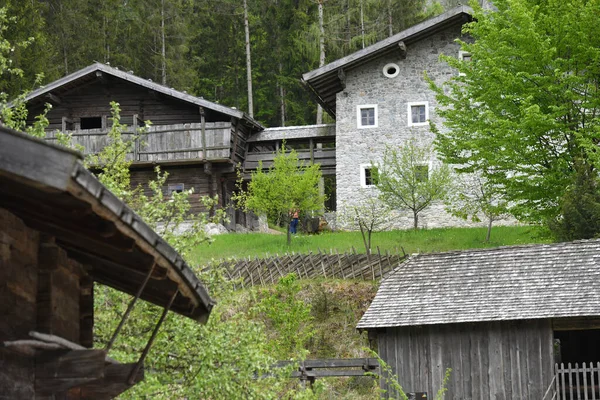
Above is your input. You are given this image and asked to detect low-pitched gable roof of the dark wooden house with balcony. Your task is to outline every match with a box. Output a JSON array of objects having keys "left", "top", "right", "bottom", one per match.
[{"left": 25, "top": 62, "right": 264, "bottom": 130}]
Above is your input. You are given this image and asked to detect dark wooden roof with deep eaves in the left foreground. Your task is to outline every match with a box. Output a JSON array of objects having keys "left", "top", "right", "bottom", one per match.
[{"left": 0, "top": 126, "right": 214, "bottom": 321}]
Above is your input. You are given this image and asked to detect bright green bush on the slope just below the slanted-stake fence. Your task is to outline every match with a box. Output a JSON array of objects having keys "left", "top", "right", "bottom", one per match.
[{"left": 257, "top": 273, "right": 314, "bottom": 360}]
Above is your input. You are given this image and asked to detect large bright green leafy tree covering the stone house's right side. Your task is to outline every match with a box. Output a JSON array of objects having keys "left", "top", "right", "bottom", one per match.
[{"left": 430, "top": 0, "right": 600, "bottom": 223}]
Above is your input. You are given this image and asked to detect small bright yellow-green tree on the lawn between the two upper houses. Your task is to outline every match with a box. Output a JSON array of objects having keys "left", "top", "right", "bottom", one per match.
[{"left": 234, "top": 145, "right": 325, "bottom": 245}]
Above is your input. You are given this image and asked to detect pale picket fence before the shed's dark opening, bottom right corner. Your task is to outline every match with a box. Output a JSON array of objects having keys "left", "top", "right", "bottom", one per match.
[{"left": 544, "top": 362, "right": 600, "bottom": 400}]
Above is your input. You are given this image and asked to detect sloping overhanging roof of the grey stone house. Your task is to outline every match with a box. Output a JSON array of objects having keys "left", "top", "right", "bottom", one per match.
[{"left": 302, "top": 6, "right": 473, "bottom": 118}]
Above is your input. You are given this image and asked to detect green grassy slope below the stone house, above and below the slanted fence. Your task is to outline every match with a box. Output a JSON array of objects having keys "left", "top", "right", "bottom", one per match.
[{"left": 195, "top": 227, "right": 548, "bottom": 400}]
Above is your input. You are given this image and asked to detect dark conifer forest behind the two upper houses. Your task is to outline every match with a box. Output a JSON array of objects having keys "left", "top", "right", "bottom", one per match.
[{"left": 0, "top": 0, "right": 464, "bottom": 126}]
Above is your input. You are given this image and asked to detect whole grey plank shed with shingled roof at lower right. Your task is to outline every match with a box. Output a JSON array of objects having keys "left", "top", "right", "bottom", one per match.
[{"left": 358, "top": 240, "right": 600, "bottom": 400}]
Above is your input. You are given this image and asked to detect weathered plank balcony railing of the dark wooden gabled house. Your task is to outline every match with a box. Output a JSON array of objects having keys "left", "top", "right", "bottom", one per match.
[{"left": 46, "top": 120, "right": 234, "bottom": 162}]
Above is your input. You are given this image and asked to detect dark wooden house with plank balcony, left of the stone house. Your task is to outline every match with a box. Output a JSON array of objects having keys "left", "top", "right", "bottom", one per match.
[{"left": 25, "top": 63, "right": 264, "bottom": 228}]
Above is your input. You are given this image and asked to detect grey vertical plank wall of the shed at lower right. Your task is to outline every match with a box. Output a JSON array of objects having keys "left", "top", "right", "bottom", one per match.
[{"left": 377, "top": 320, "right": 554, "bottom": 400}]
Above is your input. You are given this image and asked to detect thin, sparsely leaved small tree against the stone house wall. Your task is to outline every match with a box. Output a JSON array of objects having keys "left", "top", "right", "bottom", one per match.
[{"left": 377, "top": 138, "right": 452, "bottom": 229}]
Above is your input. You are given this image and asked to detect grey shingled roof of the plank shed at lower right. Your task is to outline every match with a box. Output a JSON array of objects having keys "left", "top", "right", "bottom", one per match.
[{"left": 357, "top": 240, "right": 600, "bottom": 329}]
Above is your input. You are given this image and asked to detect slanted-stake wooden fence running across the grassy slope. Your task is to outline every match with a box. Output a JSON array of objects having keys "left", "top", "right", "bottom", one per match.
[{"left": 212, "top": 247, "right": 408, "bottom": 288}]
